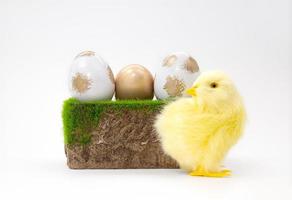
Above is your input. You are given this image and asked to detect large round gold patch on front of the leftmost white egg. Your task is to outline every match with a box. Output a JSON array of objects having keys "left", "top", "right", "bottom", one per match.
[{"left": 72, "top": 73, "right": 92, "bottom": 94}]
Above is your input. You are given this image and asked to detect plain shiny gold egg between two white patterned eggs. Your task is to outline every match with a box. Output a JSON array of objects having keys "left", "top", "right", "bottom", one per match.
[{"left": 116, "top": 64, "right": 154, "bottom": 99}]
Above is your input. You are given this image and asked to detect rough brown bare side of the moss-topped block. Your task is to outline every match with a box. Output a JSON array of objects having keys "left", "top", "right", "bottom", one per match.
[{"left": 65, "top": 108, "right": 178, "bottom": 169}]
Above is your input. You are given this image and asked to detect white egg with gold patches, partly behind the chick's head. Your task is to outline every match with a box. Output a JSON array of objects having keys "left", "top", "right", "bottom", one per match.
[{"left": 154, "top": 53, "right": 200, "bottom": 99}]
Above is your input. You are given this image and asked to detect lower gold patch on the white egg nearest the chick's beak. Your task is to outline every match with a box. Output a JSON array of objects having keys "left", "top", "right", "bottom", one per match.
[{"left": 163, "top": 76, "right": 186, "bottom": 97}]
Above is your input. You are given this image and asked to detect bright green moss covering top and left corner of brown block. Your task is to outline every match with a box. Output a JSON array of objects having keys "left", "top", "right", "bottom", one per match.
[{"left": 62, "top": 98, "right": 167, "bottom": 145}]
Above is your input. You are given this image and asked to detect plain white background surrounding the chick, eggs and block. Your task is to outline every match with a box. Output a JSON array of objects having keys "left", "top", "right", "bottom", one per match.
[{"left": 0, "top": 0, "right": 292, "bottom": 199}]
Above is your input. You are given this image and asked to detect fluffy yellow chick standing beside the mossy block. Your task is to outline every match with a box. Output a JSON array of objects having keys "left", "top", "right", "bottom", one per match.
[{"left": 155, "top": 71, "right": 245, "bottom": 177}]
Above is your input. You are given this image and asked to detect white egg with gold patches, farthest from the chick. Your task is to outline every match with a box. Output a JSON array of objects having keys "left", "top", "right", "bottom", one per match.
[{"left": 69, "top": 51, "right": 115, "bottom": 101}]
